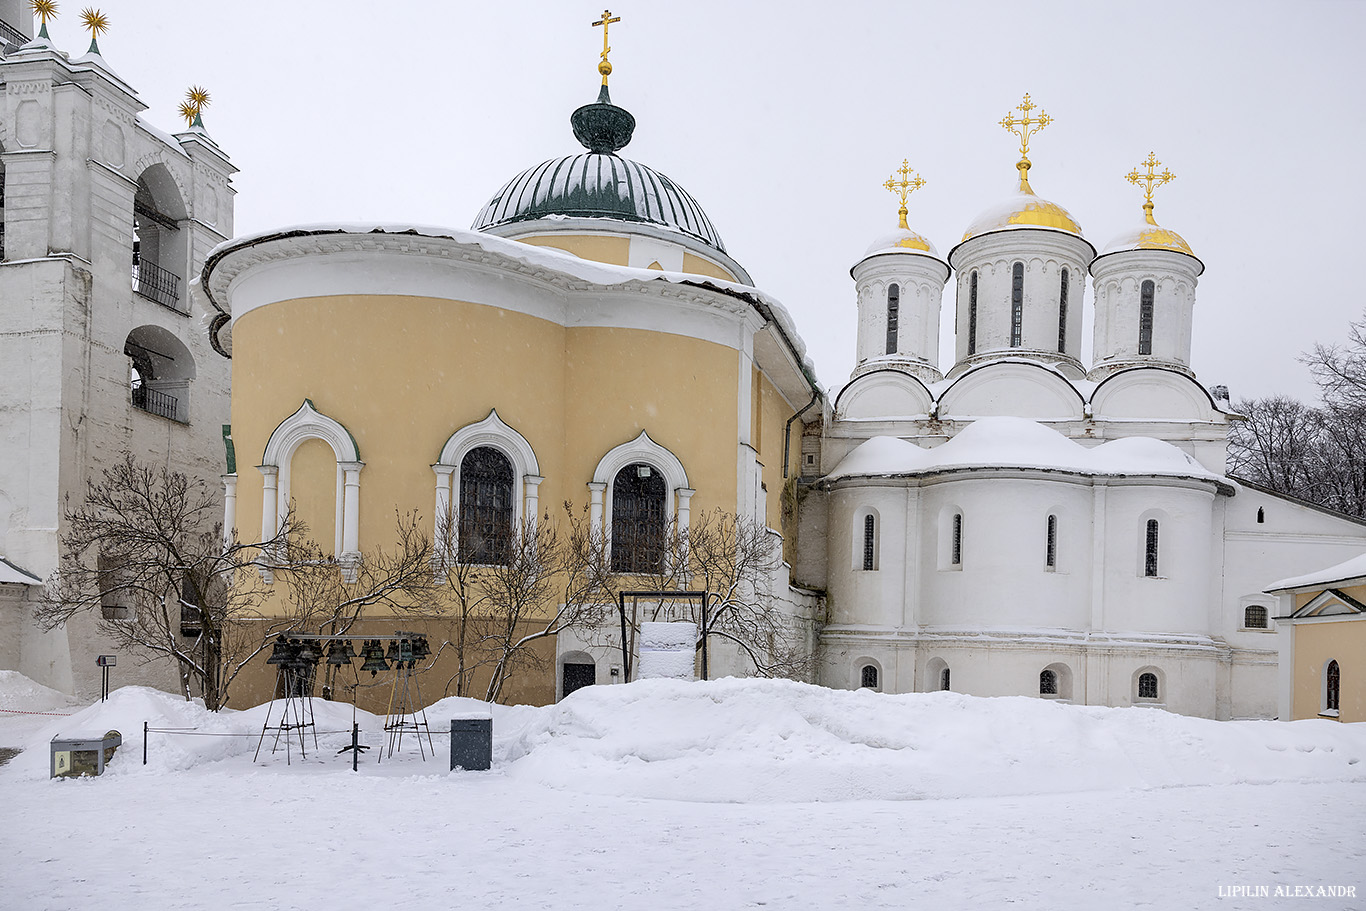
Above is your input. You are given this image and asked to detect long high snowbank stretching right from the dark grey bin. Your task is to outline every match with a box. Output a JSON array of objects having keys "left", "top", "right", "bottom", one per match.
[{"left": 494, "top": 679, "right": 1366, "bottom": 803}]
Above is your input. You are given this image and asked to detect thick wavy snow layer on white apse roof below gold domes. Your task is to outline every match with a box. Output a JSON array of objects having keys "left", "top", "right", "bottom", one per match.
[{"left": 826, "top": 417, "right": 1232, "bottom": 489}]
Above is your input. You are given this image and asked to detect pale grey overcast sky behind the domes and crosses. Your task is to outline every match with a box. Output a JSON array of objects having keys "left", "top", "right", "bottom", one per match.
[{"left": 49, "top": 0, "right": 1366, "bottom": 400}]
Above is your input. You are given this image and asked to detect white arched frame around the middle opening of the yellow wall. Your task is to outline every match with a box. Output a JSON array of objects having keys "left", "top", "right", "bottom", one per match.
[{"left": 432, "top": 408, "right": 545, "bottom": 565}]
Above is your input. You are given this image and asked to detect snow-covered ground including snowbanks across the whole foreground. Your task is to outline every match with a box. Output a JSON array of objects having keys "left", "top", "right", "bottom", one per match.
[{"left": 0, "top": 675, "right": 1366, "bottom": 910}]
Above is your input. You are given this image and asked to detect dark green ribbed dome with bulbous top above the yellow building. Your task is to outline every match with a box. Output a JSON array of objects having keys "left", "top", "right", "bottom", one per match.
[{"left": 473, "top": 83, "right": 725, "bottom": 253}]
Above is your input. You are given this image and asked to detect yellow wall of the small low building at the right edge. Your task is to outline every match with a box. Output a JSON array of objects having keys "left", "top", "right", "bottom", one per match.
[{"left": 1291, "top": 617, "right": 1366, "bottom": 721}]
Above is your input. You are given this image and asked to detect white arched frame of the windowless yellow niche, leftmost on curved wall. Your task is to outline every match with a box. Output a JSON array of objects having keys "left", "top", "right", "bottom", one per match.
[{"left": 257, "top": 399, "right": 365, "bottom": 564}]
